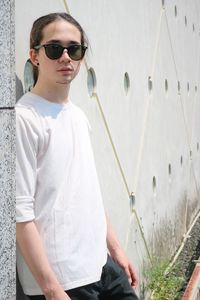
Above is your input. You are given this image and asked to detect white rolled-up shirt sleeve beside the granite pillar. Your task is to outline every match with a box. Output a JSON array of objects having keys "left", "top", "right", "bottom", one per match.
[{"left": 16, "top": 113, "right": 38, "bottom": 222}]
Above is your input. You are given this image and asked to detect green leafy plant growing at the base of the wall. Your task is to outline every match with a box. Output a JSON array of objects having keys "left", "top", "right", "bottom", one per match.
[{"left": 145, "top": 259, "right": 184, "bottom": 300}]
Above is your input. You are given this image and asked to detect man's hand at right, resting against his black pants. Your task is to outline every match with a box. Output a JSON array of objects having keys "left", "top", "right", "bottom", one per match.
[{"left": 111, "top": 249, "right": 138, "bottom": 288}]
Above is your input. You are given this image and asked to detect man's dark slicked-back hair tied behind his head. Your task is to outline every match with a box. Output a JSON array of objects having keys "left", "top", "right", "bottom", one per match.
[{"left": 30, "top": 12, "right": 88, "bottom": 85}]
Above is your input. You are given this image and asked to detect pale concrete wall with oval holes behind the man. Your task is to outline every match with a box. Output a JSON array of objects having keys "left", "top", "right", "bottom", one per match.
[{"left": 16, "top": 0, "right": 200, "bottom": 298}]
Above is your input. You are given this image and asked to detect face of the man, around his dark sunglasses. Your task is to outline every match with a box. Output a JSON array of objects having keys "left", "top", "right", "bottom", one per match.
[{"left": 32, "top": 20, "right": 81, "bottom": 85}]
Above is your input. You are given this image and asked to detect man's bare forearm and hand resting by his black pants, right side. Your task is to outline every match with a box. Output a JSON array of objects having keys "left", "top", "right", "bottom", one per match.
[{"left": 106, "top": 216, "right": 138, "bottom": 287}]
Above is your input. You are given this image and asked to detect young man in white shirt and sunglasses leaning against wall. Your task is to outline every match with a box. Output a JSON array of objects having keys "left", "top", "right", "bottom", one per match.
[{"left": 16, "top": 13, "right": 138, "bottom": 300}]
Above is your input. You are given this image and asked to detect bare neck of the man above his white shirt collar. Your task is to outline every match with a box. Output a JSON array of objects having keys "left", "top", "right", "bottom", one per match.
[{"left": 31, "top": 83, "right": 70, "bottom": 104}]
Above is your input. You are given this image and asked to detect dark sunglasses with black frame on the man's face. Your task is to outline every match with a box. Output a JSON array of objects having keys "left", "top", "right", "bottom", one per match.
[{"left": 34, "top": 44, "right": 87, "bottom": 60}]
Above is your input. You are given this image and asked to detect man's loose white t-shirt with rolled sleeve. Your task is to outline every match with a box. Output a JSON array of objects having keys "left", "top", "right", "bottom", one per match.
[{"left": 16, "top": 93, "right": 107, "bottom": 295}]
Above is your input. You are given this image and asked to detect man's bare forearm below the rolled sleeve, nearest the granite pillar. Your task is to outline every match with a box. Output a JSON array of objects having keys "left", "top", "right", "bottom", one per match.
[{"left": 16, "top": 221, "right": 70, "bottom": 300}]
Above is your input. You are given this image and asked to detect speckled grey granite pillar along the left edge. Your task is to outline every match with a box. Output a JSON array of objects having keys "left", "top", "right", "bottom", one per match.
[{"left": 0, "top": 0, "right": 15, "bottom": 300}]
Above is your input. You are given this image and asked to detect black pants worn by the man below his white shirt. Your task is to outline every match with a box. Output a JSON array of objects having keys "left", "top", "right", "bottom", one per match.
[{"left": 29, "top": 256, "right": 138, "bottom": 300}]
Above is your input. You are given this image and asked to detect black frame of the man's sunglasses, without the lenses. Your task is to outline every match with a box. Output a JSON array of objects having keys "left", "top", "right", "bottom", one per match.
[{"left": 33, "top": 43, "right": 87, "bottom": 61}]
